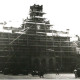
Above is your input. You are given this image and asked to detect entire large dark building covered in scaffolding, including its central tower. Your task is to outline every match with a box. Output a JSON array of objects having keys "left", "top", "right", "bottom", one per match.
[{"left": 0, "top": 4, "right": 76, "bottom": 74}]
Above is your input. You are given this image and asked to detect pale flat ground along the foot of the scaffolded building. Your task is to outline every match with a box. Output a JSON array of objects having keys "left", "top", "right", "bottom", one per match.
[{"left": 0, "top": 73, "right": 78, "bottom": 79}]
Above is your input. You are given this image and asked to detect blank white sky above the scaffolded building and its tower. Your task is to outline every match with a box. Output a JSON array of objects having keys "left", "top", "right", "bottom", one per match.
[{"left": 0, "top": 0, "right": 80, "bottom": 35}]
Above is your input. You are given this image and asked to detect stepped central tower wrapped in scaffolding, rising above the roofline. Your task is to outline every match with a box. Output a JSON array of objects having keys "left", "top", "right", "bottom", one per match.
[{"left": 23, "top": 4, "right": 52, "bottom": 31}]
